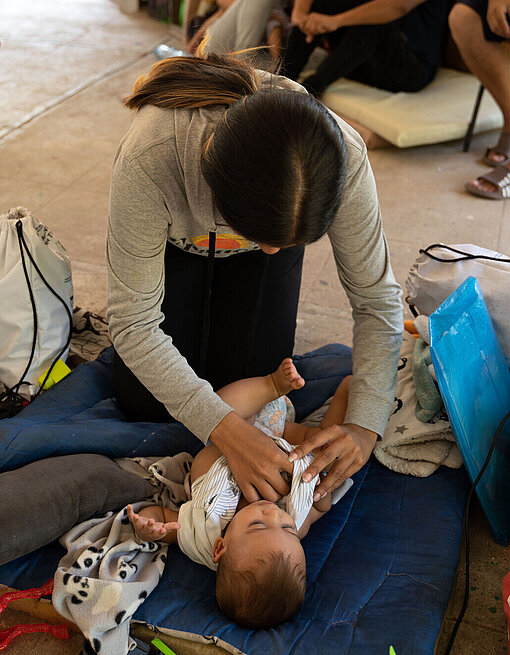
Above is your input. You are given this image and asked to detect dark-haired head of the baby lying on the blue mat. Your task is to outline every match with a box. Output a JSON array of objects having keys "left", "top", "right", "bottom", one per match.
[{"left": 213, "top": 500, "right": 306, "bottom": 629}]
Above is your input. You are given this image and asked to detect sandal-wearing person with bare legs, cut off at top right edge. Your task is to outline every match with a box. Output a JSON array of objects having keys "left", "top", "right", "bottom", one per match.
[{"left": 449, "top": 0, "right": 510, "bottom": 200}]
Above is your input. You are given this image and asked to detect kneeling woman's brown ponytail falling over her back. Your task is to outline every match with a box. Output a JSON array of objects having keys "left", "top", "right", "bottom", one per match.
[{"left": 124, "top": 53, "right": 260, "bottom": 109}]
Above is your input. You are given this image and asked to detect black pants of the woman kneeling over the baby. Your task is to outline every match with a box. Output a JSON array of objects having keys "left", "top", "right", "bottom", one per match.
[{"left": 114, "top": 244, "right": 304, "bottom": 421}]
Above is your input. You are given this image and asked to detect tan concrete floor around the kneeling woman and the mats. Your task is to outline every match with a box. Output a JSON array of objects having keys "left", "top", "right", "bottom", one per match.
[{"left": 0, "top": 0, "right": 510, "bottom": 655}]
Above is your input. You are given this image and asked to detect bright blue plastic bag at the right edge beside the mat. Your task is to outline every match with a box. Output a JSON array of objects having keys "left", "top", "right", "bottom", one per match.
[{"left": 429, "top": 277, "right": 510, "bottom": 545}]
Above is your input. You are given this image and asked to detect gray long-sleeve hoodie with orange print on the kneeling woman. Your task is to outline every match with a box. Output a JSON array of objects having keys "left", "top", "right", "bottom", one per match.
[{"left": 107, "top": 75, "right": 402, "bottom": 443}]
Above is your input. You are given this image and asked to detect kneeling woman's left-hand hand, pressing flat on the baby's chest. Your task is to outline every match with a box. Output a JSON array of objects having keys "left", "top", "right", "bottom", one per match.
[{"left": 210, "top": 412, "right": 294, "bottom": 503}]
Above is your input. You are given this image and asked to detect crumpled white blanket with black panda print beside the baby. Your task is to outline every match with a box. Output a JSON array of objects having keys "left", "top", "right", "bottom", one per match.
[{"left": 53, "top": 453, "right": 192, "bottom": 655}]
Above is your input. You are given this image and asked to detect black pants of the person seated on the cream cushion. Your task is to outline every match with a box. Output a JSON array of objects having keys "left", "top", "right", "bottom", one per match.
[{"left": 282, "top": 0, "right": 435, "bottom": 96}]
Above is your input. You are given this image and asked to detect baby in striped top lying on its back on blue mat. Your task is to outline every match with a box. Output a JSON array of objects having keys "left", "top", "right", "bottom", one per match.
[{"left": 128, "top": 359, "right": 352, "bottom": 629}]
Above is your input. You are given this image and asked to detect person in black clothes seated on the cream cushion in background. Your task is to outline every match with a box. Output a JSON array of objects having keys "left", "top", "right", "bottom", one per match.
[{"left": 282, "top": 0, "right": 450, "bottom": 96}]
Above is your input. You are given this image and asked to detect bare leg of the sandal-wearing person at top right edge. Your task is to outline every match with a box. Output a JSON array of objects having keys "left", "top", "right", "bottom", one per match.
[{"left": 448, "top": 3, "right": 510, "bottom": 191}]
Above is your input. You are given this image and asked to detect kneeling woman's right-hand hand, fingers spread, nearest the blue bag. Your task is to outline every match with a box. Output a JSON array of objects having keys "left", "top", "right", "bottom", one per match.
[{"left": 289, "top": 423, "right": 377, "bottom": 501}]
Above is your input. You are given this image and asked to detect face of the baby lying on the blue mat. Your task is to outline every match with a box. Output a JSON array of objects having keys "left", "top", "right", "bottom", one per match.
[{"left": 225, "top": 500, "right": 305, "bottom": 569}]
